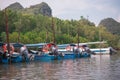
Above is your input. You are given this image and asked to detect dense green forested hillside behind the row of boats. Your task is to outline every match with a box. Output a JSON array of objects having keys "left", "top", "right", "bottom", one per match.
[{"left": 0, "top": 2, "right": 120, "bottom": 47}]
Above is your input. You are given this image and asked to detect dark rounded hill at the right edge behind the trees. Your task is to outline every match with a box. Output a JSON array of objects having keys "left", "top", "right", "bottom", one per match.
[{"left": 99, "top": 18, "right": 120, "bottom": 35}]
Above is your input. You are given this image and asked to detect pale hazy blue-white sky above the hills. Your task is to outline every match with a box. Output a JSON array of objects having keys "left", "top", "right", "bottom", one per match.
[{"left": 0, "top": 0, "right": 120, "bottom": 24}]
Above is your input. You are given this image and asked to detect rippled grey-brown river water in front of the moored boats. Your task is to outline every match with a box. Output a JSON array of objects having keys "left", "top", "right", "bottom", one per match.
[{"left": 0, "top": 52, "right": 120, "bottom": 80}]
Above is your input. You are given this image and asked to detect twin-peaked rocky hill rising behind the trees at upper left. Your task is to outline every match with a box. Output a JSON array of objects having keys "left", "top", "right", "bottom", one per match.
[{"left": 7, "top": 2, "right": 52, "bottom": 16}]
